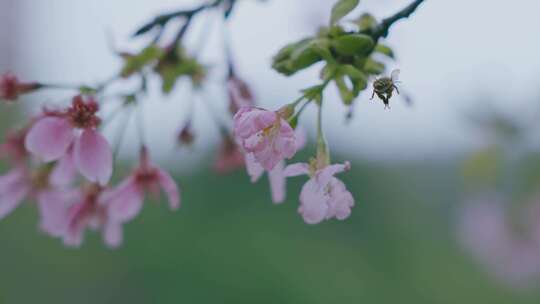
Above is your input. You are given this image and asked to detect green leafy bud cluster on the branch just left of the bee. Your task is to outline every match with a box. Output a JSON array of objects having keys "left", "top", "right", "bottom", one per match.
[{"left": 272, "top": 0, "right": 394, "bottom": 105}]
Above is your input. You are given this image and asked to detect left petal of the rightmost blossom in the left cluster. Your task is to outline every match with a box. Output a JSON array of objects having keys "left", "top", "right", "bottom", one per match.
[{"left": 104, "top": 177, "right": 144, "bottom": 222}]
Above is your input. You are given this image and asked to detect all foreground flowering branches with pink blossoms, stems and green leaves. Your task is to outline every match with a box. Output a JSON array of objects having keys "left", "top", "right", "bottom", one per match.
[{"left": 0, "top": 0, "right": 423, "bottom": 247}]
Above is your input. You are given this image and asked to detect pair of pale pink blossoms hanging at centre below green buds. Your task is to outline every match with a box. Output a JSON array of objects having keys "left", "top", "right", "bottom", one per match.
[{"left": 234, "top": 106, "right": 354, "bottom": 224}]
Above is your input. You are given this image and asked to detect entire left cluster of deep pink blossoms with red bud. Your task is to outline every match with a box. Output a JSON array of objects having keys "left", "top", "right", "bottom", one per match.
[{"left": 0, "top": 74, "right": 180, "bottom": 247}]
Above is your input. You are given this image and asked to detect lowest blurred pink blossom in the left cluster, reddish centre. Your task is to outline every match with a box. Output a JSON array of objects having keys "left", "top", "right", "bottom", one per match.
[{"left": 62, "top": 184, "right": 123, "bottom": 248}]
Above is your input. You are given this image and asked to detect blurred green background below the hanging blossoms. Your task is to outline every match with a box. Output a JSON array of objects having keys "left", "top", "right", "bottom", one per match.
[{"left": 0, "top": 156, "right": 540, "bottom": 304}]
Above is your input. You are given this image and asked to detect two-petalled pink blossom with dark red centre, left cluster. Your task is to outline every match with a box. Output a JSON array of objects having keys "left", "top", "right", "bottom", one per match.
[{"left": 25, "top": 95, "right": 112, "bottom": 185}]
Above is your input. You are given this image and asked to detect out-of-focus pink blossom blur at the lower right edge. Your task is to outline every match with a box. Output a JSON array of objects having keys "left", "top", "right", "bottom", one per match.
[{"left": 458, "top": 194, "right": 540, "bottom": 288}]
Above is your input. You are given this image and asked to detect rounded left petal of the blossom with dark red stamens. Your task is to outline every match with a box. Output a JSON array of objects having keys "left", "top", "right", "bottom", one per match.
[{"left": 25, "top": 117, "right": 73, "bottom": 162}]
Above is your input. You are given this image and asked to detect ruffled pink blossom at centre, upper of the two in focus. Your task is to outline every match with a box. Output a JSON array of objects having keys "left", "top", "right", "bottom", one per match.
[{"left": 234, "top": 107, "right": 296, "bottom": 171}]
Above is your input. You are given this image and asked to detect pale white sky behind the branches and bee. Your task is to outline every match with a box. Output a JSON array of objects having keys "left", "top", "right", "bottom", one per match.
[{"left": 4, "top": 0, "right": 540, "bottom": 169}]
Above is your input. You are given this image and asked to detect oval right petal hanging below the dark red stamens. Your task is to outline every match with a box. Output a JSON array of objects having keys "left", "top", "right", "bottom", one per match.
[{"left": 74, "top": 129, "right": 112, "bottom": 185}]
